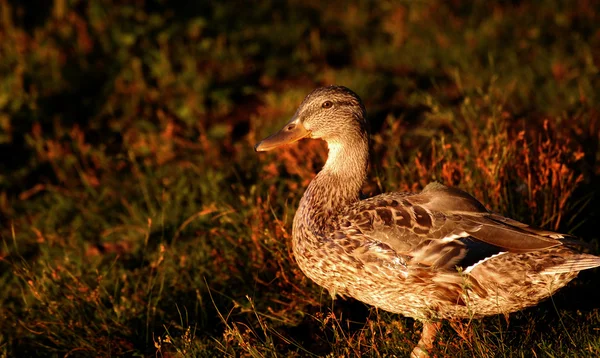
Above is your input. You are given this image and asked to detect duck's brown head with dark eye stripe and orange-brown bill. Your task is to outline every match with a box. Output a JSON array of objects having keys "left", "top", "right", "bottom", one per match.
[{"left": 254, "top": 86, "right": 367, "bottom": 152}]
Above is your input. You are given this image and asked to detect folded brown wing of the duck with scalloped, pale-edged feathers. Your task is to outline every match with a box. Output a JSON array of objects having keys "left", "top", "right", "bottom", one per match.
[{"left": 331, "top": 183, "right": 566, "bottom": 270}]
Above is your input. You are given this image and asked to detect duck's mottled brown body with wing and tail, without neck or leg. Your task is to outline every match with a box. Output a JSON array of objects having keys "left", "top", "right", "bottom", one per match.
[{"left": 295, "top": 183, "right": 600, "bottom": 318}]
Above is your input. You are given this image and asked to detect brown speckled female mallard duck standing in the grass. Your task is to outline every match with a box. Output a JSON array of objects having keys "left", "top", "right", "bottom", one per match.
[{"left": 255, "top": 86, "right": 600, "bottom": 357}]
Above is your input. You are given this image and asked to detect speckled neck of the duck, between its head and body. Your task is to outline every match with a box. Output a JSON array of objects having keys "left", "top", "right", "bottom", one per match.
[{"left": 294, "top": 135, "right": 369, "bottom": 237}]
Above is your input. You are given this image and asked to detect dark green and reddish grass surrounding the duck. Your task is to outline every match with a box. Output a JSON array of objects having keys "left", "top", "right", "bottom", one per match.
[{"left": 0, "top": 0, "right": 600, "bottom": 357}]
